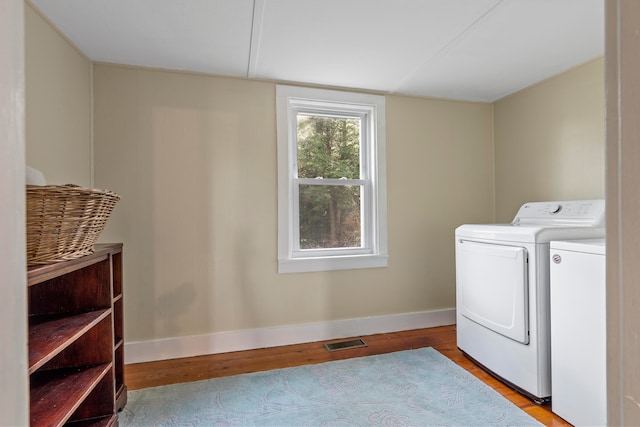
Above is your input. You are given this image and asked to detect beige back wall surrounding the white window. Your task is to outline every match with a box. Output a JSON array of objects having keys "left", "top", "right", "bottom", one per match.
[{"left": 94, "top": 65, "right": 493, "bottom": 341}]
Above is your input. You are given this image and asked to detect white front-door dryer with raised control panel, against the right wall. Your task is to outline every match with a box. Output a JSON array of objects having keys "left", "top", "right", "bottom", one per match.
[{"left": 455, "top": 200, "right": 605, "bottom": 403}]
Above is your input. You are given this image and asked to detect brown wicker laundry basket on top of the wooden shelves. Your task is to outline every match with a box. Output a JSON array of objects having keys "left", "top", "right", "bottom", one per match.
[{"left": 26, "top": 185, "right": 120, "bottom": 266}]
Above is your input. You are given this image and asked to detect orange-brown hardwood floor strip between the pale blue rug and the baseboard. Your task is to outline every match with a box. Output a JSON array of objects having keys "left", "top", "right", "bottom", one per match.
[{"left": 125, "top": 326, "right": 571, "bottom": 426}]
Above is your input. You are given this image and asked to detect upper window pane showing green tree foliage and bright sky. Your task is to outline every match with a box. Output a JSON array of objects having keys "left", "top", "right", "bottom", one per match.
[{"left": 297, "top": 114, "right": 360, "bottom": 179}]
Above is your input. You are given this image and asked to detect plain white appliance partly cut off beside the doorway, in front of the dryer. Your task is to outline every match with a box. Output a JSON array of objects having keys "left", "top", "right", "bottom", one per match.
[{"left": 550, "top": 239, "right": 607, "bottom": 426}]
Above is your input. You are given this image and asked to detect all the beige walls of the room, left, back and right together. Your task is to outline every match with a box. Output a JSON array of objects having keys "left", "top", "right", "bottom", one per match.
[{"left": 26, "top": 6, "right": 604, "bottom": 354}]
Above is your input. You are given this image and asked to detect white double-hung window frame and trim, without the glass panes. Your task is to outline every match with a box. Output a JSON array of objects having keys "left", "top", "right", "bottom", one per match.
[{"left": 276, "top": 85, "right": 388, "bottom": 273}]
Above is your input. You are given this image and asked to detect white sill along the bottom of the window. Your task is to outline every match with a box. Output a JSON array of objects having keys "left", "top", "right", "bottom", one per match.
[{"left": 278, "top": 255, "right": 389, "bottom": 273}]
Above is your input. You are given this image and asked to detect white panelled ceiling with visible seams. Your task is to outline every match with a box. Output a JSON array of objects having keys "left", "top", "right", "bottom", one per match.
[{"left": 31, "top": 0, "right": 604, "bottom": 102}]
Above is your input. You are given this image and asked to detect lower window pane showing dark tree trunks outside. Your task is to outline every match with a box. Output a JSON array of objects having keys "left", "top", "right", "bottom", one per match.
[{"left": 300, "top": 184, "right": 362, "bottom": 249}]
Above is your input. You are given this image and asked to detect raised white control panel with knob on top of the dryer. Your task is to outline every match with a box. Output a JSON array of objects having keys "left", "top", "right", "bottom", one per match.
[{"left": 512, "top": 200, "right": 605, "bottom": 227}]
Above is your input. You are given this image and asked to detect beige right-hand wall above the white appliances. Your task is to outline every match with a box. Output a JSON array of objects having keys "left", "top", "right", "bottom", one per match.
[{"left": 494, "top": 58, "right": 605, "bottom": 222}]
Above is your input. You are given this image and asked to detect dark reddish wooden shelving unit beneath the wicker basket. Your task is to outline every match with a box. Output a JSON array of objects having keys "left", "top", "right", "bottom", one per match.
[{"left": 27, "top": 244, "right": 127, "bottom": 426}]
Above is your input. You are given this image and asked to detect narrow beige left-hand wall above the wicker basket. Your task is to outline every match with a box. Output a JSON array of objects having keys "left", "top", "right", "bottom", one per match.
[{"left": 25, "top": 2, "right": 93, "bottom": 186}]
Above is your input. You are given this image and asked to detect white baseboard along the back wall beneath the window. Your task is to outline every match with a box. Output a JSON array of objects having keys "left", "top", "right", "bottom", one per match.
[{"left": 124, "top": 308, "right": 456, "bottom": 364}]
